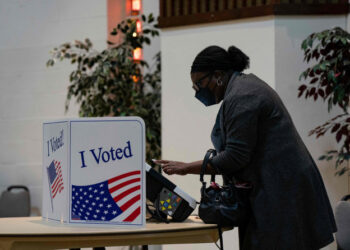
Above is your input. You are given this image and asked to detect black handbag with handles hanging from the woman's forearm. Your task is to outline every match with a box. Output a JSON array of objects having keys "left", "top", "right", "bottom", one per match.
[{"left": 198, "top": 149, "right": 250, "bottom": 228}]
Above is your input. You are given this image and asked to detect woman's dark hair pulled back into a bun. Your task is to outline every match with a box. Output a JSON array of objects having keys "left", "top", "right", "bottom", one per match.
[{"left": 191, "top": 46, "right": 249, "bottom": 73}]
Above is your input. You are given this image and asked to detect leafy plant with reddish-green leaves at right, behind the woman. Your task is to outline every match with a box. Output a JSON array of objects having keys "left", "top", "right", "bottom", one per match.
[{"left": 298, "top": 27, "right": 350, "bottom": 176}]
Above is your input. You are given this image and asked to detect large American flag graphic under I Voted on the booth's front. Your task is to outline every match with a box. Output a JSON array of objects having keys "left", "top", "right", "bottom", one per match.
[{"left": 72, "top": 170, "right": 141, "bottom": 222}]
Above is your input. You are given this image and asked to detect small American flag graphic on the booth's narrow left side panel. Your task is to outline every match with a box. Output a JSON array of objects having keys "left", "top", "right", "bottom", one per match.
[{"left": 47, "top": 160, "right": 64, "bottom": 199}]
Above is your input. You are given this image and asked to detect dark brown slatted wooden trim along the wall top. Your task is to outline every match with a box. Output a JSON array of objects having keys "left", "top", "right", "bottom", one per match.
[{"left": 158, "top": 0, "right": 349, "bottom": 28}]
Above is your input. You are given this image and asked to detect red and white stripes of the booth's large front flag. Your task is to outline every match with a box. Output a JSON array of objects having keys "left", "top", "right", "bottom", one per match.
[{"left": 108, "top": 170, "right": 141, "bottom": 222}]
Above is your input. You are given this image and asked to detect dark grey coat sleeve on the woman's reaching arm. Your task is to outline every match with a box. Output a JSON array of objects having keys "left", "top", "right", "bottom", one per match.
[{"left": 211, "top": 95, "right": 260, "bottom": 175}]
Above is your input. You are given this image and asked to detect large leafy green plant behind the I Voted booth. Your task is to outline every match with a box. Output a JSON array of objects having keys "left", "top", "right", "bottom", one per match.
[{"left": 47, "top": 14, "right": 161, "bottom": 162}]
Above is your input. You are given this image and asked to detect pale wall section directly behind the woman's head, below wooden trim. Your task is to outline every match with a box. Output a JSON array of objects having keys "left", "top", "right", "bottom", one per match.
[{"left": 161, "top": 17, "right": 275, "bottom": 250}]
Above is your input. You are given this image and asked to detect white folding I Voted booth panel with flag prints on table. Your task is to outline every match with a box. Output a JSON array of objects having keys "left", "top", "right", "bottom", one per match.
[{"left": 42, "top": 117, "right": 146, "bottom": 227}]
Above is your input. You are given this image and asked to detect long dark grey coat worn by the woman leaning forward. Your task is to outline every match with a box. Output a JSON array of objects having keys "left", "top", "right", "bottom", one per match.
[{"left": 211, "top": 74, "right": 336, "bottom": 250}]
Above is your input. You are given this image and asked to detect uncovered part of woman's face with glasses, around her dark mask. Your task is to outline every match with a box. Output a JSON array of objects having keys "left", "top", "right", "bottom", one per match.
[{"left": 191, "top": 72, "right": 225, "bottom": 103}]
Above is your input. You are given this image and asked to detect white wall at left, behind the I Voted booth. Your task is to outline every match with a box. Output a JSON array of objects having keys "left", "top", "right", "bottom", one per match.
[{"left": 0, "top": 0, "right": 107, "bottom": 215}]
